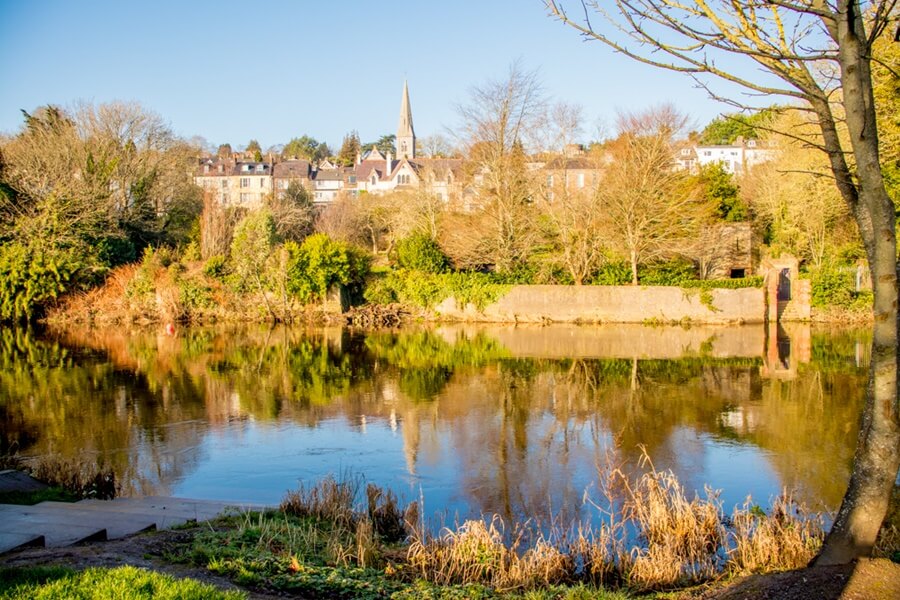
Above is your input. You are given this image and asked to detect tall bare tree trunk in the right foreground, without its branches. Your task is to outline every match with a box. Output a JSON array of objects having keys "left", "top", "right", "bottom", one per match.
[{"left": 813, "top": 0, "right": 900, "bottom": 565}]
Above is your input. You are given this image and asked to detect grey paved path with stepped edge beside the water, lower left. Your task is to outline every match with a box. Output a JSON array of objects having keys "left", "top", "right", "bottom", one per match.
[{"left": 0, "top": 496, "right": 271, "bottom": 554}]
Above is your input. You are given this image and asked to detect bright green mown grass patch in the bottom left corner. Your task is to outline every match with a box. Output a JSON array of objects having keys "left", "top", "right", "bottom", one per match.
[{"left": 0, "top": 567, "right": 247, "bottom": 600}]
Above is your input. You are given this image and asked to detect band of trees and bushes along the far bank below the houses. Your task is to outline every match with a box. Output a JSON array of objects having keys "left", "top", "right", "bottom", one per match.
[{"left": 0, "top": 96, "right": 893, "bottom": 322}]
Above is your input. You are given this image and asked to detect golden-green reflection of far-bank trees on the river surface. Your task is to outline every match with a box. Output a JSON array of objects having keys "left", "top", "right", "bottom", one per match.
[{"left": 0, "top": 327, "right": 864, "bottom": 517}]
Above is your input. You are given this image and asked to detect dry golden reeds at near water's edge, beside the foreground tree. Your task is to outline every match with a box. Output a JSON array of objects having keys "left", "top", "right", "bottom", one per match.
[{"left": 407, "top": 456, "right": 823, "bottom": 590}]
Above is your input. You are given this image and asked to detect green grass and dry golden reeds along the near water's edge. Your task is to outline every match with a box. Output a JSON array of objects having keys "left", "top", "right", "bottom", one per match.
[{"left": 155, "top": 457, "right": 823, "bottom": 600}]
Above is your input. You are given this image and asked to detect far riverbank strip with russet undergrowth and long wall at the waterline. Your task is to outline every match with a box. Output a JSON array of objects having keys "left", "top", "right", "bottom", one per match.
[{"left": 45, "top": 259, "right": 871, "bottom": 327}]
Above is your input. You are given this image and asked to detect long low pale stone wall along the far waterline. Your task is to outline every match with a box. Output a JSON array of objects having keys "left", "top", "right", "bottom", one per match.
[{"left": 435, "top": 285, "right": 766, "bottom": 324}]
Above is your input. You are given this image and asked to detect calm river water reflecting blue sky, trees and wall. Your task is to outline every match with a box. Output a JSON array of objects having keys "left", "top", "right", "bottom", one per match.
[{"left": 0, "top": 326, "right": 871, "bottom": 517}]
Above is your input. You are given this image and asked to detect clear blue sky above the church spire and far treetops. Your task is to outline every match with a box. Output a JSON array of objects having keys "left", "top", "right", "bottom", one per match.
[{"left": 0, "top": 0, "right": 744, "bottom": 148}]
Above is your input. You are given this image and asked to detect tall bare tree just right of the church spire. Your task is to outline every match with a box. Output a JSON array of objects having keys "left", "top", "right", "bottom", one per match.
[{"left": 458, "top": 63, "right": 545, "bottom": 272}]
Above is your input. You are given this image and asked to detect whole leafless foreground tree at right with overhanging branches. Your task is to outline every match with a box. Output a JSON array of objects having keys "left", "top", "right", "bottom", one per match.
[{"left": 545, "top": 0, "right": 900, "bottom": 564}]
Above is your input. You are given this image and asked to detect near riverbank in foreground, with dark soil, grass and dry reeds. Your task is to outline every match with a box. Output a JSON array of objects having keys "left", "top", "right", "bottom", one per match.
[{"left": 0, "top": 474, "right": 900, "bottom": 600}]
